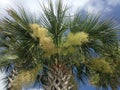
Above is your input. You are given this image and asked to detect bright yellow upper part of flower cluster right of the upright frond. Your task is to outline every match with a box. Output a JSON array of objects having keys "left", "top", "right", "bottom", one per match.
[{"left": 65, "top": 32, "right": 88, "bottom": 47}]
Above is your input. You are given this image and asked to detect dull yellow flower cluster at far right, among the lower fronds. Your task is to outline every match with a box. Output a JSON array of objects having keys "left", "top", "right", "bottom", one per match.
[{"left": 90, "top": 58, "right": 113, "bottom": 73}]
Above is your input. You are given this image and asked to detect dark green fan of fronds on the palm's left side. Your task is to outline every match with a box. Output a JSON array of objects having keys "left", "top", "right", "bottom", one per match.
[{"left": 1, "top": 7, "right": 42, "bottom": 66}]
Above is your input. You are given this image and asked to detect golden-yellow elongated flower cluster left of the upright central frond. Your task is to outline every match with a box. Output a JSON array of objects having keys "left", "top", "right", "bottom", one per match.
[{"left": 30, "top": 24, "right": 55, "bottom": 56}]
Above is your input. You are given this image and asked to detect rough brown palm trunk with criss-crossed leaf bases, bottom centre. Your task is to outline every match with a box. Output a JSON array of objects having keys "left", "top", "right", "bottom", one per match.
[{"left": 40, "top": 64, "right": 74, "bottom": 90}]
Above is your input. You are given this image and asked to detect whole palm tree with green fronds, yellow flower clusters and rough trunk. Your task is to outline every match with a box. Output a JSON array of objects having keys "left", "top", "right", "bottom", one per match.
[{"left": 0, "top": 0, "right": 120, "bottom": 90}]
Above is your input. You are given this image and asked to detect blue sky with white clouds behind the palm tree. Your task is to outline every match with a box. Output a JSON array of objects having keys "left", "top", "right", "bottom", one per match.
[{"left": 0, "top": 0, "right": 120, "bottom": 90}]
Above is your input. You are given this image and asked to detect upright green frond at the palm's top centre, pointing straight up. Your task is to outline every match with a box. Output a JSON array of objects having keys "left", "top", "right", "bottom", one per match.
[{"left": 41, "top": 0, "right": 68, "bottom": 46}]
